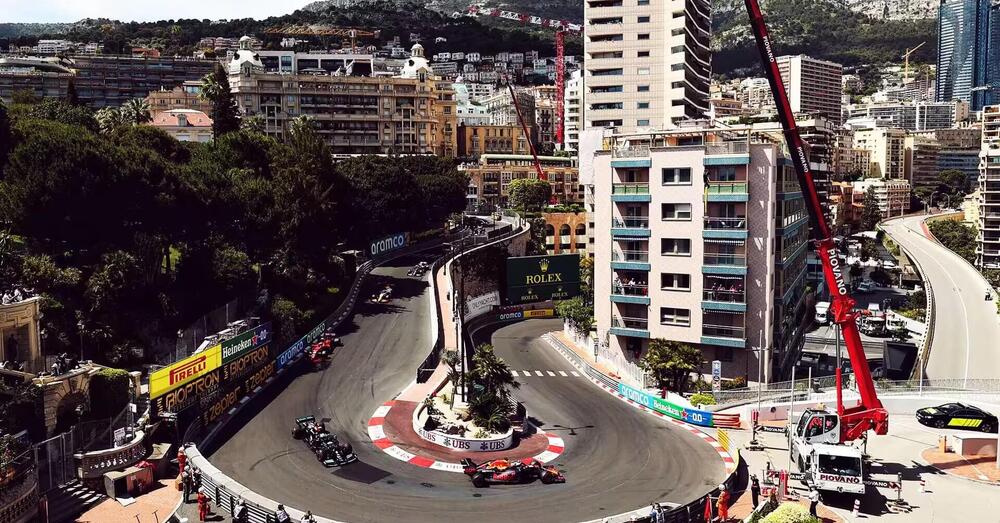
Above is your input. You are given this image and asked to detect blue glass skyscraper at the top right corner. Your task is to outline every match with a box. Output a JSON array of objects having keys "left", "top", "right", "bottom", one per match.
[{"left": 935, "top": 0, "right": 1000, "bottom": 111}]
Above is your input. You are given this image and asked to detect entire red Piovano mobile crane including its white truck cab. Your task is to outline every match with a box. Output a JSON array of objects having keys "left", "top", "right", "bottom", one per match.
[{"left": 744, "top": 0, "right": 889, "bottom": 493}]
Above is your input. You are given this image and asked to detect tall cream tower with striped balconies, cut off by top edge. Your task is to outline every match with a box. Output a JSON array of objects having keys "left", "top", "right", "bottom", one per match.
[{"left": 583, "top": 0, "right": 712, "bottom": 133}]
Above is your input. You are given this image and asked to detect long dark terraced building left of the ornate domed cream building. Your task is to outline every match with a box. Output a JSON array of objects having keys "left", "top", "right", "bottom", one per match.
[{"left": 68, "top": 55, "right": 217, "bottom": 109}]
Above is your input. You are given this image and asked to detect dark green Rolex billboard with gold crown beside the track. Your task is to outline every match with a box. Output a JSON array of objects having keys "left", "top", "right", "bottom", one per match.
[{"left": 506, "top": 254, "right": 580, "bottom": 305}]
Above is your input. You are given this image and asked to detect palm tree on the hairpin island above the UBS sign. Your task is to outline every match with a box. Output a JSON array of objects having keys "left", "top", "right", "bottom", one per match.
[{"left": 469, "top": 344, "right": 520, "bottom": 432}]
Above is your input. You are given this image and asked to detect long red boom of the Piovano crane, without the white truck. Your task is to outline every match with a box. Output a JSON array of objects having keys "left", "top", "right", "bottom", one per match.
[{"left": 744, "top": 0, "right": 889, "bottom": 441}]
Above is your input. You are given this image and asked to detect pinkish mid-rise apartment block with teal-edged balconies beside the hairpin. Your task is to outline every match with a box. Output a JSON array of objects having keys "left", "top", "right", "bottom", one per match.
[{"left": 591, "top": 128, "right": 809, "bottom": 380}]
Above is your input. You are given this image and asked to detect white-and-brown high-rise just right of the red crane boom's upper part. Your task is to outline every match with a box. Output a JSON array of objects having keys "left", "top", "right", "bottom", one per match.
[{"left": 777, "top": 55, "right": 844, "bottom": 125}]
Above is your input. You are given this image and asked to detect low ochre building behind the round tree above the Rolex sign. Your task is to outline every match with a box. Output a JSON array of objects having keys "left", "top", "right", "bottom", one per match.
[{"left": 459, "top": 154, "right": 583, "bottom": 208}]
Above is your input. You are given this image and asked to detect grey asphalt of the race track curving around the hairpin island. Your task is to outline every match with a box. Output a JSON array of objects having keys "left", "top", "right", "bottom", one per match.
[{"left": 209, "top": 253, "right": 724, "bottom": 523}]
